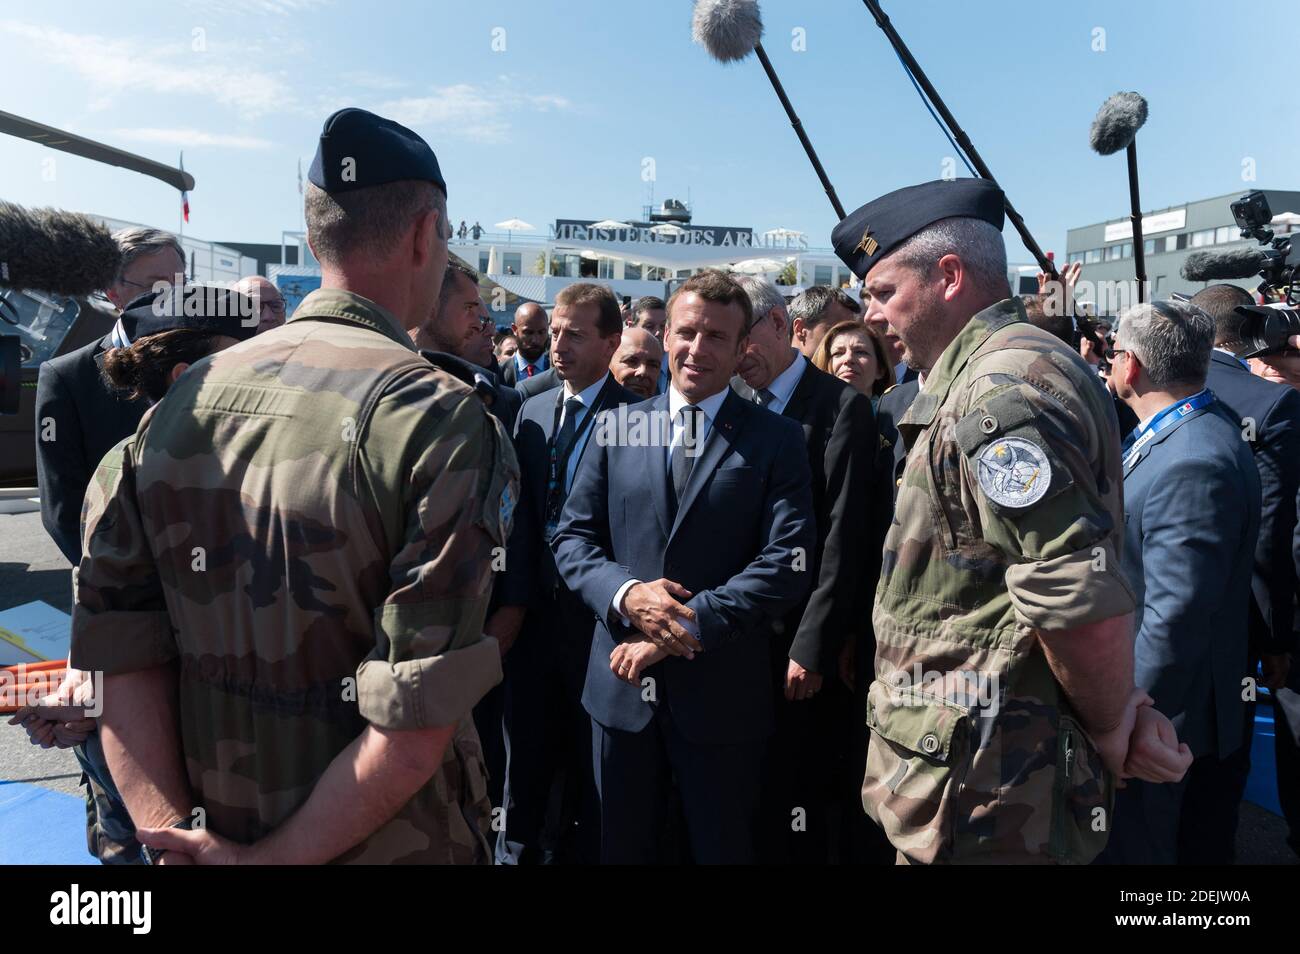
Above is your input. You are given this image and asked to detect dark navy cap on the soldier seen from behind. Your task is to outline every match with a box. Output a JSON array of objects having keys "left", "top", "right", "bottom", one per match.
[{"left": 307, "top": 107, "right": 447, "bottom": 195}]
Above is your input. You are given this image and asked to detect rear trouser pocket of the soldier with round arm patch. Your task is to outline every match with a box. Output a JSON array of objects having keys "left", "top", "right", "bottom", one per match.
[{"left": 1048, "top": 715, "right": 1115, "bottom": 864}]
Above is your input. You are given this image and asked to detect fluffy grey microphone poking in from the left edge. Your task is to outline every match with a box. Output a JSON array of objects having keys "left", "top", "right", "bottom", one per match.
[{"left": 0, "top": 201, "right": 122, "bottom": 298}]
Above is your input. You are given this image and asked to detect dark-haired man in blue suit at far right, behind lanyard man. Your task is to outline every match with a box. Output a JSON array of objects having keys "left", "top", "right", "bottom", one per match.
[{"left": 1179, "top": 285, "right": 1300, "bottom": 864}]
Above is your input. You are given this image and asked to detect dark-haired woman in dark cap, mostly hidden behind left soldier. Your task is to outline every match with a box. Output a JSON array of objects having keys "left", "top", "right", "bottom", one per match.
[{"left": 9, "top": 285, "right": 259, "bottom": 864}]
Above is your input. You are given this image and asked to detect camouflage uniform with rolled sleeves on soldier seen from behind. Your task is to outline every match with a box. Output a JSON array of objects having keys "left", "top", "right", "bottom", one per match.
[{"left": 72, "top": 290, "right": 519, "bottom": 863}]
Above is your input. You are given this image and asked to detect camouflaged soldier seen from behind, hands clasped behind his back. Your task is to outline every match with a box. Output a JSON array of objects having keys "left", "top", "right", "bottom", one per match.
[{"left": 73, "top": 109, "right": 517, "bottom": 863}]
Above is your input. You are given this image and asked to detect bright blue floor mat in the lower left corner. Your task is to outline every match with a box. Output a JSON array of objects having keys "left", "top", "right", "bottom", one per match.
[{"left": 0, "top": 781, "right": 99, "bottom": 864}]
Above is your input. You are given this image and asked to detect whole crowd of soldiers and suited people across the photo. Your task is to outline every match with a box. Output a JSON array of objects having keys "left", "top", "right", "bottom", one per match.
[{"left": 13, "top": 109, "right": 1300, "bottom": 864}]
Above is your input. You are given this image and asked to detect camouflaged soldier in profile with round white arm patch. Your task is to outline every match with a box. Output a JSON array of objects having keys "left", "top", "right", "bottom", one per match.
[{"left": 833, "top": 179, "right": 1190, "bottom": 863}]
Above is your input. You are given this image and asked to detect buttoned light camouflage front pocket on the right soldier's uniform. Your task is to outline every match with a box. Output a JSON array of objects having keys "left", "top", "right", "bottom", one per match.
[{"left": 862, "top": 680, "right": 971, "bottom": 864}]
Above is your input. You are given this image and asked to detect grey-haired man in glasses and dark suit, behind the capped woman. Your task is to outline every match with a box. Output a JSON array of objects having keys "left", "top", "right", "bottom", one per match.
[{"left": 36, "top": 227, "right": 185, "bottom": 567}]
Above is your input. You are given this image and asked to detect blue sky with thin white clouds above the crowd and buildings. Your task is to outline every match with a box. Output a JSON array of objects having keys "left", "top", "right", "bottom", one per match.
[{"left": 0, "top": 0, "right": 1300, "bottom": 261}]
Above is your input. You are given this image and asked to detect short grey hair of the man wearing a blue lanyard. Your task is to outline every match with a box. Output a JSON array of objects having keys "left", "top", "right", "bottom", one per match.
[{"left": 1115, "top": 302, "right": 1214, "bottom": 389}]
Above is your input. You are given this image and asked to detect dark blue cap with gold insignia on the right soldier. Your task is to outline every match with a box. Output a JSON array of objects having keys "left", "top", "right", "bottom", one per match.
[{"left": 831, "top": 179, "right": 1006, "bottom": 278}]
